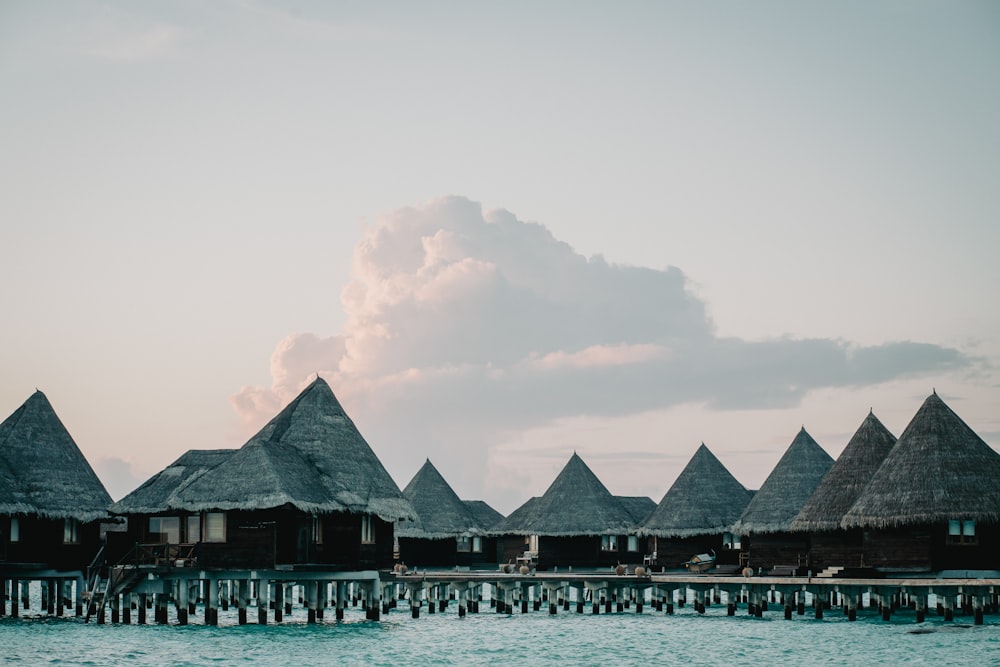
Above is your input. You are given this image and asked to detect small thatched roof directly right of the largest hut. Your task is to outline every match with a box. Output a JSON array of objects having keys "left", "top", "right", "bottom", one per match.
[{"left": 396, "top": 459, "right": 495, "bottom": 540}]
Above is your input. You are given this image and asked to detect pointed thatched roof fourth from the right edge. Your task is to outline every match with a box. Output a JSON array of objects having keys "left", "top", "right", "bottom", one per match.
[{"left": 639, "top": 443, "right": 753, "bottom": 537}]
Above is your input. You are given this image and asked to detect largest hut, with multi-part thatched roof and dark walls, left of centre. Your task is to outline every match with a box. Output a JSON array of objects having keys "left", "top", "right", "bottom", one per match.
[{"left": 111, "top": 377, "right": 416, "bottom": 571}]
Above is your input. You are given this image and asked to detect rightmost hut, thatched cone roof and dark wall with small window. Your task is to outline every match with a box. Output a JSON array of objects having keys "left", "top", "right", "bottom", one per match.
[{"left": 841, "top": 392, "right": 1000, "bottom": 572}]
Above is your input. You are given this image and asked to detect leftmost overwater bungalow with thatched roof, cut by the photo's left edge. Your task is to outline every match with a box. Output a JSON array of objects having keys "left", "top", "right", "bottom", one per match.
[{"left": 0, "top": 390, "right": 111, "bottom": 613}]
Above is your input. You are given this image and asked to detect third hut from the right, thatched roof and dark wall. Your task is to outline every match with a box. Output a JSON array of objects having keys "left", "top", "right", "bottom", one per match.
[{"left": 730, "top": 427, "right": 833, "bottom": 573}]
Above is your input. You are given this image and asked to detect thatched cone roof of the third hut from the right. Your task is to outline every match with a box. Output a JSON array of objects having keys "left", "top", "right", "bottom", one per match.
[{"left": 731, "top": 427, "right": 833, "bottom": 535}]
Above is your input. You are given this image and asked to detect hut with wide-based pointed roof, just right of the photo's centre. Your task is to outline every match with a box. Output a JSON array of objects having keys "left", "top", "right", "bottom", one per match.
[{"left": 493, "top": 452, "right": 653, "bottom": 570}]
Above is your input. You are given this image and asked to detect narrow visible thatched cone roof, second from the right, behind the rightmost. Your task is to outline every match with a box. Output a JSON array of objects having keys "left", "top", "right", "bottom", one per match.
[{"left": 791, "top": 412, "right": 896, "bottom": 532}]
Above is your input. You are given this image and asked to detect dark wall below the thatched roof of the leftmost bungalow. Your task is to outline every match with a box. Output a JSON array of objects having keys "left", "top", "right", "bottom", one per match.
[{"left": 0, "top": 514, "right": 101, "bottom": 570}]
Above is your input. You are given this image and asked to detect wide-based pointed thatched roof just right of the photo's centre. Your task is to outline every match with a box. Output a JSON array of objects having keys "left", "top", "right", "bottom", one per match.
[{"left": 491, "top": 453, "right": 636, "bottom": 537}]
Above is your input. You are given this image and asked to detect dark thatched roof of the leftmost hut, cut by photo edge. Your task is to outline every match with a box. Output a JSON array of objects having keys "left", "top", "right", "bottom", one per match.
[{"left": 0, "top": 390, "right": 111, "bottom": 522}]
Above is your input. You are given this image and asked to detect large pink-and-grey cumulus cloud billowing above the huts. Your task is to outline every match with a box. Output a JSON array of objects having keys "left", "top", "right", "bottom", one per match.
[{"left": 233, "top": 197, "right": 968, "bottom": 500}]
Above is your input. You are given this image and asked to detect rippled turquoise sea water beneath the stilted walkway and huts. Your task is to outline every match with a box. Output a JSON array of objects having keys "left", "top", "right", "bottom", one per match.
[{"left": 0, "top": 603, "right": 1000, "bottom": 666}]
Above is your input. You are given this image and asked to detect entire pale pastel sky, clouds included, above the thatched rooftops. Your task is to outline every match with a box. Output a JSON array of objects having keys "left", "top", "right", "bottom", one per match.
[{"left": 0, "top": 0, "right": 1000, "bottom": 514}]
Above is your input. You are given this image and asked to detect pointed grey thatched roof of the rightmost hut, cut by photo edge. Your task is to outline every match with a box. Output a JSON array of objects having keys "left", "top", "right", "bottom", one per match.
[{"left": 841, "top": 393, "right": 1000, "bottom": 528}]
